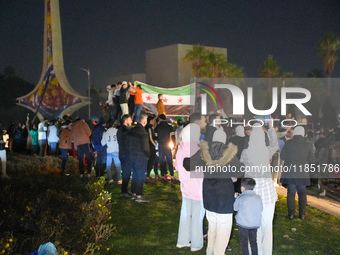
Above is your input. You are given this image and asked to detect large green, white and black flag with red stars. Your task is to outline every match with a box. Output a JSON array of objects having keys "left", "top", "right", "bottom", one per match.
[{"left": 136, "top": 81, "right": 194, "bottom": 116}]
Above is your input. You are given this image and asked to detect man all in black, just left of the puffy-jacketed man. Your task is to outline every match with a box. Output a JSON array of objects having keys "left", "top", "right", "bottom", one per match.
[{"left": 117, "top": 114, "right": 132, "bottom": 197}]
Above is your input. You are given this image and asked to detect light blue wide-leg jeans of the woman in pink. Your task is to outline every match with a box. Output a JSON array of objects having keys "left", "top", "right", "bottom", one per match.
[{"left": 177, "top": 197, "right": 205, "bottom": 249}]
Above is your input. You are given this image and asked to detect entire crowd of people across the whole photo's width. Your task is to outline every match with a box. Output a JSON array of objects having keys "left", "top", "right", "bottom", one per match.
[{"left": 0, "top": 82, "right": 340, "bottom": 254}]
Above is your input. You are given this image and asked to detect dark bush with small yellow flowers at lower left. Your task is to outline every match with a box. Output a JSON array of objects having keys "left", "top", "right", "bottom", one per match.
[{"left": 0, "top": 154, "right": 115, "bottom": 254}]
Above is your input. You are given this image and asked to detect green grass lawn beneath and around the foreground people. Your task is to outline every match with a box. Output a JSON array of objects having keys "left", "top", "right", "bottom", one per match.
[{"left": 104, "top": 178, "right": 340, "bottom": 255}]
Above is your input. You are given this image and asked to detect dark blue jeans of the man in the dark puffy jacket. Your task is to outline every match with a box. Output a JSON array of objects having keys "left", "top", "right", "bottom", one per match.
[{"left": 130, "top": 158, "right": 148, "bottom": 196}]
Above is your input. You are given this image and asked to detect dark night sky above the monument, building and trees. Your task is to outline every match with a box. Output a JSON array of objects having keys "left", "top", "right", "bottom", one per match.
[{"left": 0, "top": 0, "right": 340, "bottom": 94}]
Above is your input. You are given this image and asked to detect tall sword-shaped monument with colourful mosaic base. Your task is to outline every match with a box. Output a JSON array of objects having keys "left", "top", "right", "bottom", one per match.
[{"left": 16, "top": 0, "right": 90, "bottom": 119}]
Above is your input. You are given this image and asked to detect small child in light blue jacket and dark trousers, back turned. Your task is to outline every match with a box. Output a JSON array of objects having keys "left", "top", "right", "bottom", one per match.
[{"left": 234, "top": 178, "right": 262, "bottom": 255}]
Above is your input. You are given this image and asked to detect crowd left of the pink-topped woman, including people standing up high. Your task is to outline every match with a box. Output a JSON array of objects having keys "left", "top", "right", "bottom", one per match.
[{"left": 0, "top": 81, "right": 179, "bottom": 202}]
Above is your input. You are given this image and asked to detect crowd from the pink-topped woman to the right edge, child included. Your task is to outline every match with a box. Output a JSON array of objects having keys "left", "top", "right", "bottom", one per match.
[{"left": 176, "top": 113, "right": 340, "bottom": 254}]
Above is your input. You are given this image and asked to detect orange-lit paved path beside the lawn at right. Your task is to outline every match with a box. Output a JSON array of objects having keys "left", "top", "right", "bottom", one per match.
[{"left": 276, "top": 186, "right": 340, "bottom": 218}]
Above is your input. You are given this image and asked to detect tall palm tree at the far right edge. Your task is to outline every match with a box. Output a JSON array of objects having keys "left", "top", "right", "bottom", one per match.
[{"left": 319, "top": 32, "right": 340, "bottom": 95}]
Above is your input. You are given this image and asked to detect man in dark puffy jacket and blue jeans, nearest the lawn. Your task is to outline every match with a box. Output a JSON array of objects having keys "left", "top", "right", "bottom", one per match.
[{"left": 126, "top": 114, "right": 150, "bottom": 202}]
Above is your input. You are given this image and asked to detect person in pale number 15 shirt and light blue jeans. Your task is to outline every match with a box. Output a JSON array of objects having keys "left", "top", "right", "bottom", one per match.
[{"left": 101, "top": 120, "right": 122, "bottom": 184}]
